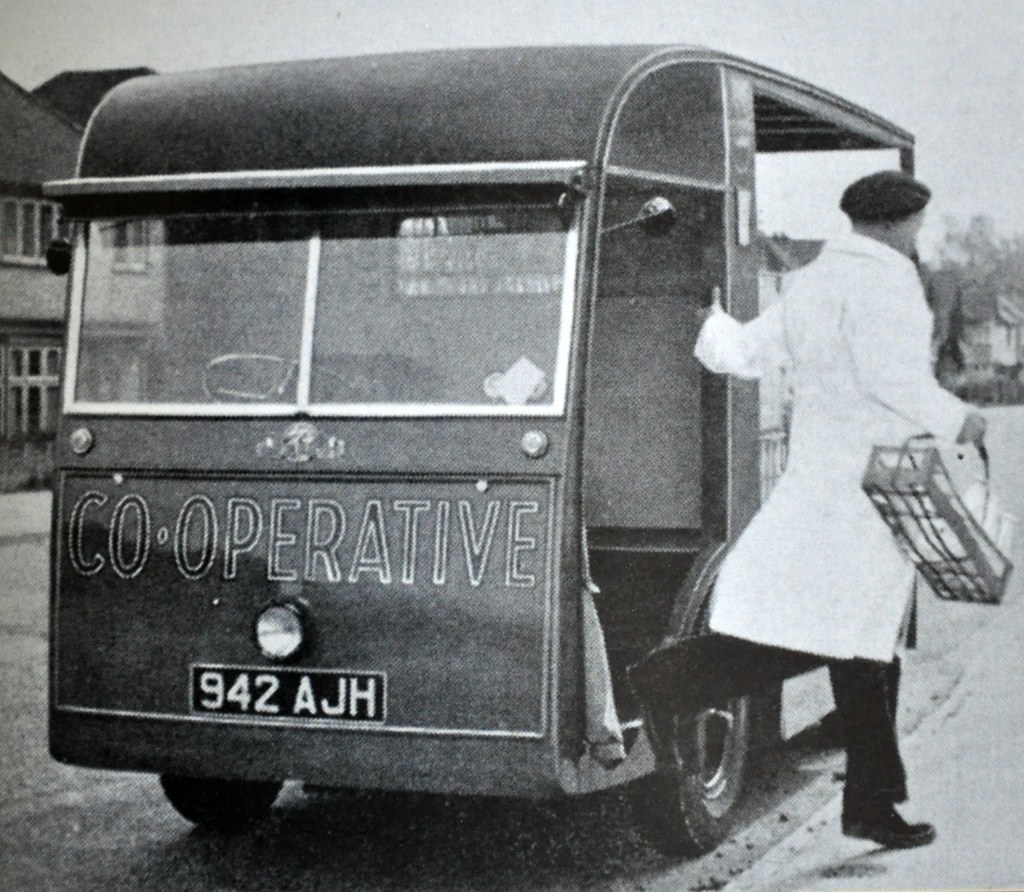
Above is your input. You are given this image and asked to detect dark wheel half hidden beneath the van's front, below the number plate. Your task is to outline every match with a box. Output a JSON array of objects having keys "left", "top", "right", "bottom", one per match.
[{"left": 160, "top": 774, "right": 282, "bottom": 832}]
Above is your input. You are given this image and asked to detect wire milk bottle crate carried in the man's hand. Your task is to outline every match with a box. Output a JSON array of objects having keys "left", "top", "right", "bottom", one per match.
[{"left": 862, "top": 437, "right": 1015, "bottom": 604}]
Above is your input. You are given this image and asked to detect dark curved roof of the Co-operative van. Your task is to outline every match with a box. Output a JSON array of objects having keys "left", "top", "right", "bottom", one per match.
[{"left": 50, "top": 46, "right": 913, "bottom": 195}]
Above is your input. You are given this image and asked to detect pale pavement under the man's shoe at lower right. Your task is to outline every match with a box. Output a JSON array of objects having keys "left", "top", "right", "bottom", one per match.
[{"left": 725, "top": 581, "right": 1024, "bottom": 892}]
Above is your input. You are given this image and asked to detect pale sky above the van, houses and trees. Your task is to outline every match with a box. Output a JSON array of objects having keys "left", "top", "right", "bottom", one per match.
[{"left": 0, "top": 0, "right": 1024, "bottom": 258}]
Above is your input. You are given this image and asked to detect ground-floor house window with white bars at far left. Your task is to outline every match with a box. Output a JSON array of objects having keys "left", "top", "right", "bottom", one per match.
[{"left": 2, "top": 345, "right": 60, "bottom": 437}]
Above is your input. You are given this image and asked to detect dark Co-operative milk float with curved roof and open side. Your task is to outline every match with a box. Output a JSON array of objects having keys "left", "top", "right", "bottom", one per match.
[{"left": 47, "top": 46, "right": 912, "bottom": 851}]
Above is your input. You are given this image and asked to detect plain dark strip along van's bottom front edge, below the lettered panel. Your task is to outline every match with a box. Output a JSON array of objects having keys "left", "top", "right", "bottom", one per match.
[{"left": 50, "top": 708, "right": 563, "bottom": 797}]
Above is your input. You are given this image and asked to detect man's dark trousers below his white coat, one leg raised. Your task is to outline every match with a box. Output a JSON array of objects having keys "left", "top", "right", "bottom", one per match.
[{"left": 630, "top": 634, "right": 906, "bottom": 817}]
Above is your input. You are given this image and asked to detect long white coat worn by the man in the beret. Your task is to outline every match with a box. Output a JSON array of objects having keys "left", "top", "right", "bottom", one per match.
[{"left": 694, "top": 233, "right": 969, "bottom": 661}]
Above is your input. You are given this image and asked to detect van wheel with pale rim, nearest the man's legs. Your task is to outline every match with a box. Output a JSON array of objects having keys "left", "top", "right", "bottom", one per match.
[{"left": 634, "top": 696, "right": 751, "bottom": 856}]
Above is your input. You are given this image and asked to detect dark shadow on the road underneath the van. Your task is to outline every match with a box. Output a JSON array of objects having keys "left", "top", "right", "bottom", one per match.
[{"left": 132, "top": 729, "right": 847, "bottom": 890}]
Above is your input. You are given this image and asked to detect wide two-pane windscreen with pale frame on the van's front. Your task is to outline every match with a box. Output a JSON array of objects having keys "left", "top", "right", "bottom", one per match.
[{"left": 73, "top": 205, "right": 572, "bottom": 415}]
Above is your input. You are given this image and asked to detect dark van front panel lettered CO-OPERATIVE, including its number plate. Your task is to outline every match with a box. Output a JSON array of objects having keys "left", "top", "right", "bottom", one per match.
[{"left": 53, "top": 472, "right": 556, "bottom": 789}]
